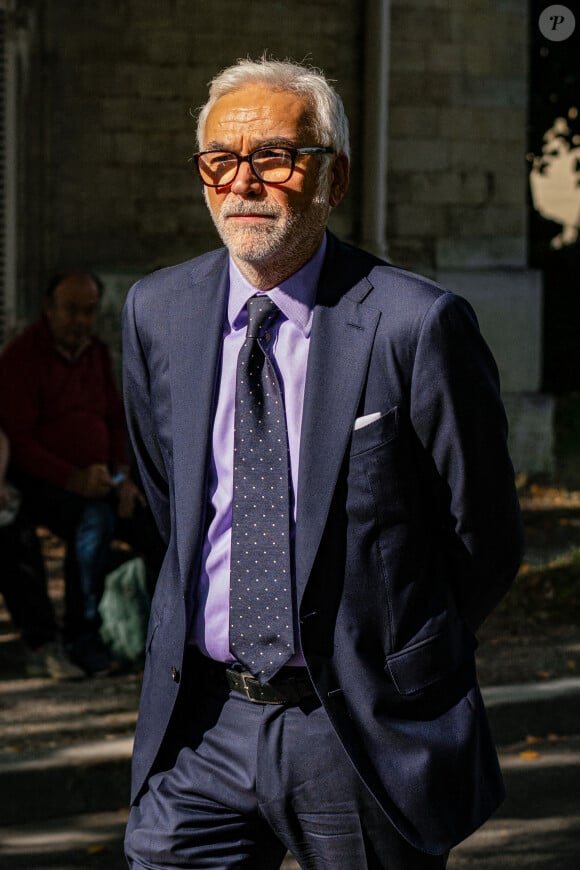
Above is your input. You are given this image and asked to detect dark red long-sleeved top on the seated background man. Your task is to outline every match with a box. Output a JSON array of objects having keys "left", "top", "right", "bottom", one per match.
[{"left": 0, "top": 319, "right": 126, "bottom": 487}]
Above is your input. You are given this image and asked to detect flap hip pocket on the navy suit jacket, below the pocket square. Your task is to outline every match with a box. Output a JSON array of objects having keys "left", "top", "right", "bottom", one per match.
[{"left": 385, "top": 633, "right": 458, "bottom": 695}]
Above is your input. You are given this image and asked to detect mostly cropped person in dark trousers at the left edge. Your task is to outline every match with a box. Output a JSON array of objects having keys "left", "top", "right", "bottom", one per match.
[{"left": 0, "top": 429, "right": 84, "bottom": 680}]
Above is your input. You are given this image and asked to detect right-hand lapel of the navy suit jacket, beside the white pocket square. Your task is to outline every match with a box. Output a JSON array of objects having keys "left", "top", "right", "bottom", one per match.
[{"left": 296, "top": 242, "right": 380, "bottom": 601}]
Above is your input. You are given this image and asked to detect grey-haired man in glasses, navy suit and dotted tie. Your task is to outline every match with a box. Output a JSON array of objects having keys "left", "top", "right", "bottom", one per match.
[{"left": 124, "top": 59, "right": 521, "bottom": 870}]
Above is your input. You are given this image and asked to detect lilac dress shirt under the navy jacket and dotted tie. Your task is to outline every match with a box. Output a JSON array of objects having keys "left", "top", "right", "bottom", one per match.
[{"left": 190, "top": 238, "right": 326, "bottom": 665}]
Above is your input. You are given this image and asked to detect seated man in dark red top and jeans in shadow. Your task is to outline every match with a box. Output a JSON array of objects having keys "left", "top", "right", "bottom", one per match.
[{"left": 0, "top": 272, "right": 162, "bottom": 674}]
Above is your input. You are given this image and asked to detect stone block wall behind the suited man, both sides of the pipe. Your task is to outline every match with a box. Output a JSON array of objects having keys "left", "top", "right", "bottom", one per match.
[{"left": 19, "top": 0, "right": 551, "bottom": 470}]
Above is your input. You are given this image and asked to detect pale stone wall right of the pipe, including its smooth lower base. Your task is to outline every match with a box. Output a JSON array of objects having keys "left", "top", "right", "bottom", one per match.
[{"left": 387, "top": 0, "right": 554, "bottom": 472}]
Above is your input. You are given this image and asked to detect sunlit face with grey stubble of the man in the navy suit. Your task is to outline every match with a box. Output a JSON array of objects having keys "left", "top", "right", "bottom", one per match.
[{"left": 203, "top": 85, "right": 342, "bottom": 274}]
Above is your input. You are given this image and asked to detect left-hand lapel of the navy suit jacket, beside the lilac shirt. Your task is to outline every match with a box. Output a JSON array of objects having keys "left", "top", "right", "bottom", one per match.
[{"left": 170, "top": 252, "right": 228, "bottom": 592}]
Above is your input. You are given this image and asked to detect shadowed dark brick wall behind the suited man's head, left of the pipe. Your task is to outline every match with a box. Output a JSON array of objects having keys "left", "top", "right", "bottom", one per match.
[{"left": 21, "top": 0, "right": 363, "bottom": 304}]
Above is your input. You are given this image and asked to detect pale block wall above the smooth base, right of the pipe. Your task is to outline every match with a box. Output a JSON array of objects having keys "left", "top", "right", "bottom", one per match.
[{"left": 388, "top": 0, "right": 528, "bottom": 274}]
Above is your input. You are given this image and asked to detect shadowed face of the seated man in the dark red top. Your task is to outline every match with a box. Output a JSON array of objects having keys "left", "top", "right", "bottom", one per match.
[{"left": 45, "top": 274, "right": 99, "bottom": 353}]
